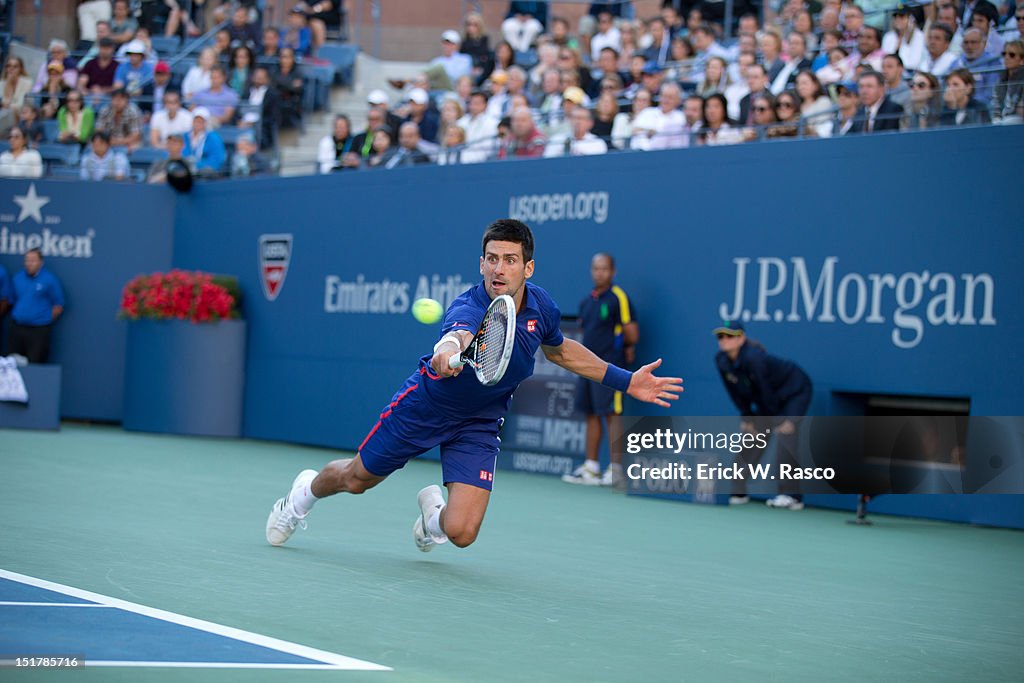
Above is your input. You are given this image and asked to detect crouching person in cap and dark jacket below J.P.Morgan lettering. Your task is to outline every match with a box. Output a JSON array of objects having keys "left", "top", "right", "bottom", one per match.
[{"left": 714, "top": 321, "right": 813, "bottom": 510}]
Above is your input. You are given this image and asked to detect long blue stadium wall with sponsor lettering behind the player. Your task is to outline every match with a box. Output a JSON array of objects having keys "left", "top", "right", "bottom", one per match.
[{"left": 0, "top": 126, "right": 1024, "bottom": 528}]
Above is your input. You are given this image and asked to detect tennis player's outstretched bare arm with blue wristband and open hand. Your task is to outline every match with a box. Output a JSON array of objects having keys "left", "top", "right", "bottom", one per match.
[{"left": 542, "top": 339, "right": 683, "bottom": 408}]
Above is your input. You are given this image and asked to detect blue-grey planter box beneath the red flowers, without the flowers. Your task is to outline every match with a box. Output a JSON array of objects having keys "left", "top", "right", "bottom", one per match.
[{"left": 124, "top": 319, "right": 246, "bottom": 437}]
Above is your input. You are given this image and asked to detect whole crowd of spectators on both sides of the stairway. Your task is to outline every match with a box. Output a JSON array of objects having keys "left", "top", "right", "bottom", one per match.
[{"left": 0, "top": 0, "right": 1024, "bottom": 179}]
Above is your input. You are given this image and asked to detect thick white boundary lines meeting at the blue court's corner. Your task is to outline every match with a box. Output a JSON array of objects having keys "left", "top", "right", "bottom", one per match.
[{"left": 0, "top": 569, "right": 392, "bottom": 671}]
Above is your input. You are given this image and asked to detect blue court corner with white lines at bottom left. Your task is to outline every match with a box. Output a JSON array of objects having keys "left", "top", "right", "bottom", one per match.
[{"left": 0, "top": 569, "right": 390, "bottom": 671}]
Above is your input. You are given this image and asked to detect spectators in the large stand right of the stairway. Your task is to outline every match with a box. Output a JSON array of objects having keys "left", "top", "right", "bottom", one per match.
[{"left": 318, "top": 0, "right": 1024, "bottom": 173}]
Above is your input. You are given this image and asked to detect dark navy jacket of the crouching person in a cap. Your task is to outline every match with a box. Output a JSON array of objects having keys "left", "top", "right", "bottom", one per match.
[{"left": 715, "top": 341, "right": 812, "bottom": 417}]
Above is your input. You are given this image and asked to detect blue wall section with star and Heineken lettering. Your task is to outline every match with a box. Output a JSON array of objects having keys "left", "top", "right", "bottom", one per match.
[{"left": 0, "top": 180, "right": 175, "bottom": 421}]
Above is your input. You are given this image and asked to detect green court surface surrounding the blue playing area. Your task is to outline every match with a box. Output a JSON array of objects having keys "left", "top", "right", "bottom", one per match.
[{"left": 0, "top": 425, "right": 1024, "bottom": 683}]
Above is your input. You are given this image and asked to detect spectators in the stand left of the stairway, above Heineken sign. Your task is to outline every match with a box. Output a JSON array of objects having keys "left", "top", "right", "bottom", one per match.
[{"left": 0, "top": 0, "right": 341, "bottom": 181}]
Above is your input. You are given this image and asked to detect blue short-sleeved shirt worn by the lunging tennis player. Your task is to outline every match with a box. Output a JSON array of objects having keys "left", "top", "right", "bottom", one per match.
[{"left": 407, "top": 281, "right": 564, "bottom": 420}]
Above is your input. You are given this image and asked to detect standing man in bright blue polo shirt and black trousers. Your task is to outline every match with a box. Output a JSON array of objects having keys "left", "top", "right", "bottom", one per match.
[{"left": 8, "top": 249, "right": 65, "bottom": 362}]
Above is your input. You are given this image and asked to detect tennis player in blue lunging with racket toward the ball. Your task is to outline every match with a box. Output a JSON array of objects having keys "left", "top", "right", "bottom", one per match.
[{"left": 266, "top": 219, "right": 683, "bottom": 552}]
